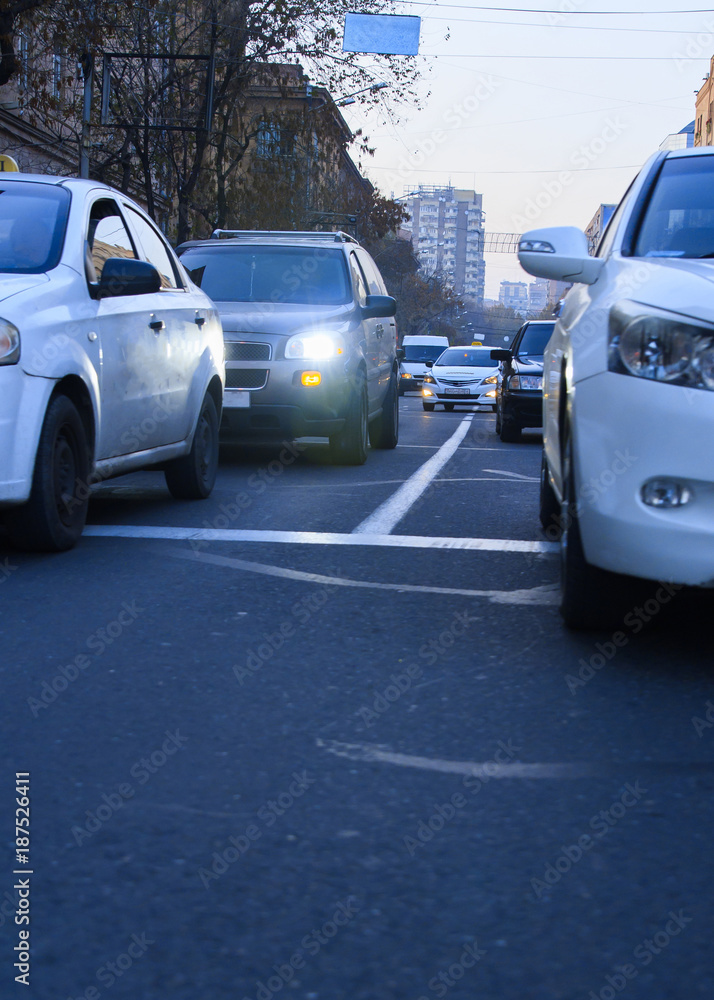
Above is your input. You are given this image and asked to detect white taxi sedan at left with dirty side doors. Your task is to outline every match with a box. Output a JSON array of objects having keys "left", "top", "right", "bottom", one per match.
[{"left": 0, "top": 174, "right": 224, "bottom": 551}]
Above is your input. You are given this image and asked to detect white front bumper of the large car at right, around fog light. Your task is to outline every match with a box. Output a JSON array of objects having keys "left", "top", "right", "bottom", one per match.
[{"left": 571, "top": 372, "right": 714, "bottom": 586}]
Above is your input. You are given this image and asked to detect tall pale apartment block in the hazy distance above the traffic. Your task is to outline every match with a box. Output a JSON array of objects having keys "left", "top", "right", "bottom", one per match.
[{"left": 404, "top": 185, "right": 486, "bottom": 305}]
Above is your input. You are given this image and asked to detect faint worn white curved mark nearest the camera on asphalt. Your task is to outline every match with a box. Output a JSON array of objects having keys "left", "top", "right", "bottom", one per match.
[{"left": 316, "top": 738, "right": 597, "bottom": 779}]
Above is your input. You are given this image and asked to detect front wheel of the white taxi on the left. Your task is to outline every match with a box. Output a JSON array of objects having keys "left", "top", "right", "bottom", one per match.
[{"left": 5, "top": 396, "right": 91, "bottom": 552}]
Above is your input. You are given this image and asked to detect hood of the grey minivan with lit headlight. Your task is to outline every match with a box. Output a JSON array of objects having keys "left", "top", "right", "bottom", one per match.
[{"left": 215, "top": 302, "right": 354, "bottom": 336}]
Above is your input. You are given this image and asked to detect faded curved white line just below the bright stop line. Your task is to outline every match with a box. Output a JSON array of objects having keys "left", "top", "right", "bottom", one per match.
[{"left": 168, "top": 549, "right": 559, "bottom": 607}]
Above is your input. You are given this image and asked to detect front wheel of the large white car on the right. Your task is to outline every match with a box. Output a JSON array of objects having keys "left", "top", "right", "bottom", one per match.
[{"left": 560, "top": 444, "right": 645, "bottom": 631}]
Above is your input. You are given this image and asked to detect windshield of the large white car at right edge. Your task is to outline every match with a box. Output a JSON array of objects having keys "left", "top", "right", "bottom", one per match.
[{"left": 634, "top": 156, "right": 714, "bottom": 257}]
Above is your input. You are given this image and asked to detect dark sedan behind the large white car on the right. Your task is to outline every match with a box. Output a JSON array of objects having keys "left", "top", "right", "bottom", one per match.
[{"left": 491, "top": 320, "right": 555, "bottom": 443}]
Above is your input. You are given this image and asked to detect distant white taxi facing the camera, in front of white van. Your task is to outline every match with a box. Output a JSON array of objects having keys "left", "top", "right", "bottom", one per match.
[{"left": 421, "top": 347, "right": 498, "bottom": 412}]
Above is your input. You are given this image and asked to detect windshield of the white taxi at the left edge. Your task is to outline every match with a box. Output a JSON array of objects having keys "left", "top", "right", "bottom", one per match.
[{"left": 0, "top": 181, "right": 70, "bottom": 274}]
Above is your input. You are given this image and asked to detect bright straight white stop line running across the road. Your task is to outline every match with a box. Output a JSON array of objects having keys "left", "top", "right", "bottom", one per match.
[{"left": 84, "top": 524, "right": 560, "bottom": 556}]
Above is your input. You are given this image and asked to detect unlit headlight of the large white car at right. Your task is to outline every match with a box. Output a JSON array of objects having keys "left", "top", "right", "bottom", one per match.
[{"left": 608, "top": 302, "right": 714, "bottom": 389}]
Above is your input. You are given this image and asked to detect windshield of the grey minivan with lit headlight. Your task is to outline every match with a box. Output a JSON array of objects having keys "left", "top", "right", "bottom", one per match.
[{"left": 181, "top": 245, "right": 352, "bottom": 305}]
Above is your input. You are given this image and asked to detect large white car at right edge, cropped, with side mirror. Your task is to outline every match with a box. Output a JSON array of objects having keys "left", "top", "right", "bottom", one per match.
[{"left": 519, "top": 147, "right": 714, "bottom": 635}]
